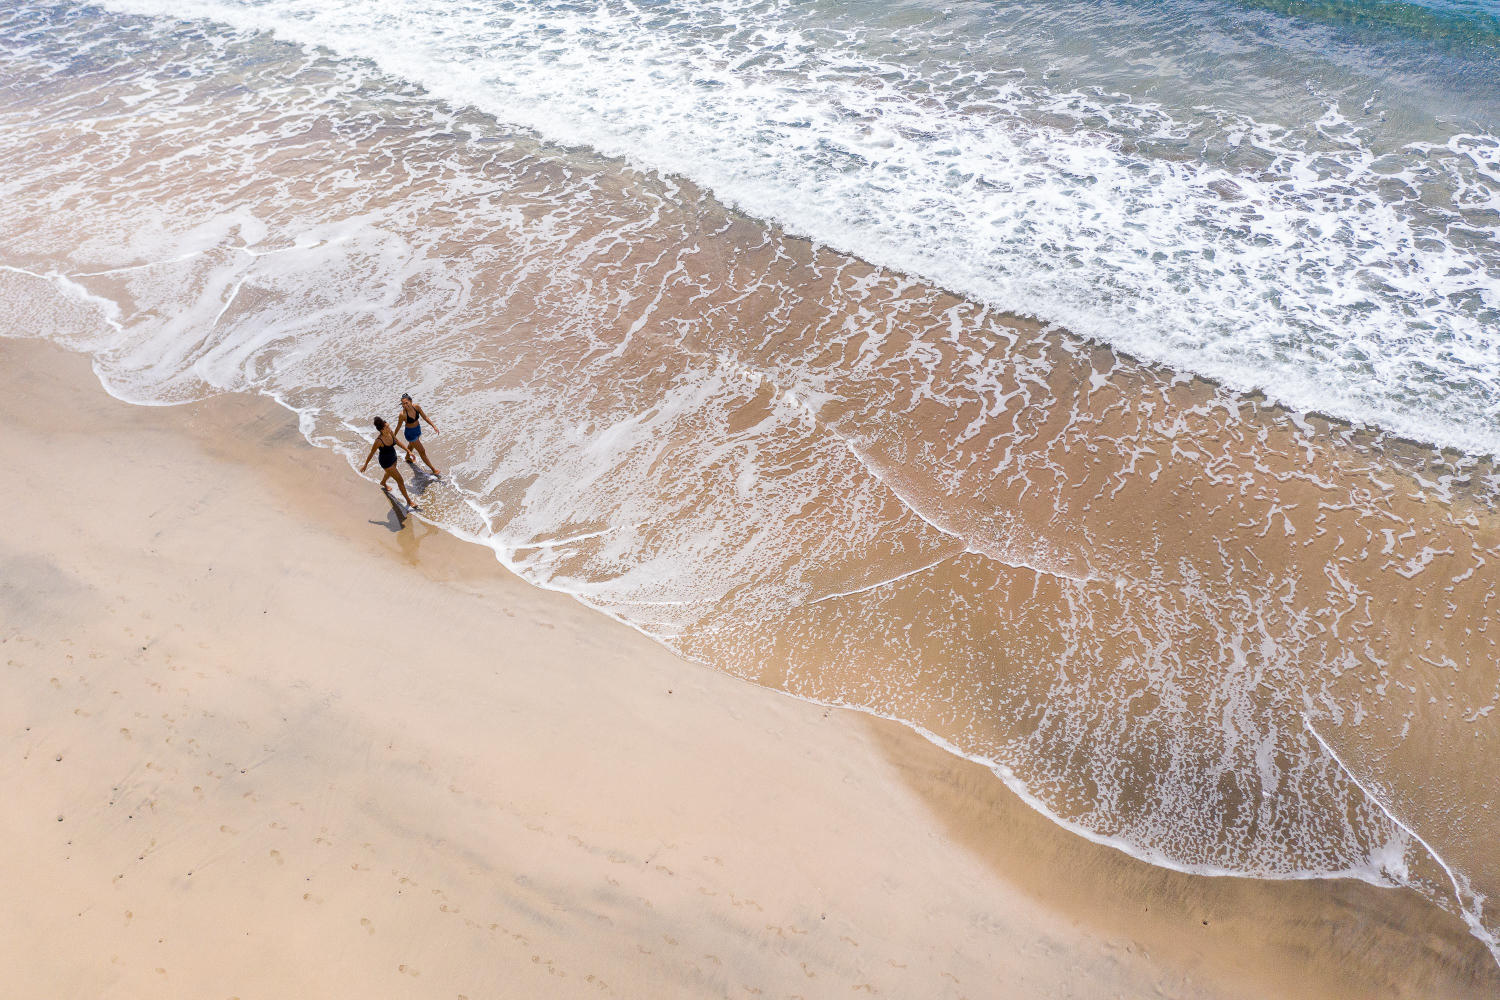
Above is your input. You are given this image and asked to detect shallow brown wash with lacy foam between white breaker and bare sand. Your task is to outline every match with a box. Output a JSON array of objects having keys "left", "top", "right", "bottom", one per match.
[{"left": 0, "top": 4, "right": 1500, "bottom": 971}]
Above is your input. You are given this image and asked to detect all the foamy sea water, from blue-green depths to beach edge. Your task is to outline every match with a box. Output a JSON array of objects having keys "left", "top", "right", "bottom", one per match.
[{"left": 0, "top": 0, "right": 1500, "bottom": 958}]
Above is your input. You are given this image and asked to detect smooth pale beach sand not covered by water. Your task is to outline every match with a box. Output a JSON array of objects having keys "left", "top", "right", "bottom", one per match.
[{"left": 0, "top": 340, "right": 1500, "bottom": 1000}]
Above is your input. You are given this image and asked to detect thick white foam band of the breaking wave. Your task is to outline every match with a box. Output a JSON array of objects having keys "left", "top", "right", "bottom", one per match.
[{"left": 87, "top": 0, "right": 1500, "bottom": 453}]
